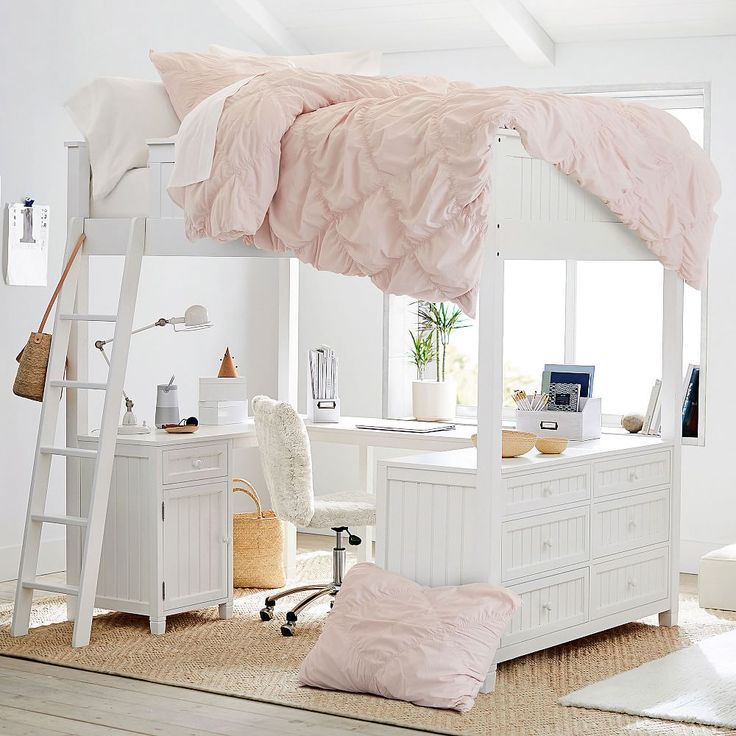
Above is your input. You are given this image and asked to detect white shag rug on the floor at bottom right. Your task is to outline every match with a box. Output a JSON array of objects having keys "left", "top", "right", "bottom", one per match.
[{"left": 559, "top": 631, "right": 736, "bottom": 728}]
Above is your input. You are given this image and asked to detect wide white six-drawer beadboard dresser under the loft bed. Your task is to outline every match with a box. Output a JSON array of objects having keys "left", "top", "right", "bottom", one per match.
[{"left": 376, "top": 435, "right": 672, "bottom": 662}]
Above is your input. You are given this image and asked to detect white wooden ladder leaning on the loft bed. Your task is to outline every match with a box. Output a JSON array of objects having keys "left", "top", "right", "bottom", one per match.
[{"left": 10, "top": 218, "right": 145, "bottom": 647}]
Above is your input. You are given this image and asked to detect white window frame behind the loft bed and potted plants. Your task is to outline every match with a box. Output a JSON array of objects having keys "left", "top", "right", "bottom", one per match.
[{"left": 382, "top": 82, "right": 711, "bottom": 446}]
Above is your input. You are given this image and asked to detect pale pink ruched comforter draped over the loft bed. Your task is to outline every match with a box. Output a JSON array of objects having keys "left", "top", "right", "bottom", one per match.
[{"left": 170, "top": 69, "right": 720, "bottom": 315}]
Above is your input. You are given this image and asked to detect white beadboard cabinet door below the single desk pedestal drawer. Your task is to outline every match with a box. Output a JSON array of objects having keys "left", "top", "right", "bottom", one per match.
[{"left": 163, "top": 481, "right": 229, "bottom": 611}]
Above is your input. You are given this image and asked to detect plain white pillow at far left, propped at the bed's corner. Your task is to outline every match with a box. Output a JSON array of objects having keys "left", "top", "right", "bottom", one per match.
[{"left": 64, "top": 77, "right": 179, "bottom": 199}]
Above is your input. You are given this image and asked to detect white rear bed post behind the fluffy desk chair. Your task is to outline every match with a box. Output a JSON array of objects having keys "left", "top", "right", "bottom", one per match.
[{"left": 277, "top": 258, "right": 299, "bottom": 578}]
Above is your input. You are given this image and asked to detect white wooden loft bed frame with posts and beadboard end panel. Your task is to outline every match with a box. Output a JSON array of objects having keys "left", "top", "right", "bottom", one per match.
[{"left": 54, "top": 130, "right": 683, "bottom": 658}]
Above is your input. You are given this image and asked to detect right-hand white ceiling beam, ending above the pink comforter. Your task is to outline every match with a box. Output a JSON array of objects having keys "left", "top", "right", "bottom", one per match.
[{"left": 470, "top": 0, "right": 555, "bottom": 66}]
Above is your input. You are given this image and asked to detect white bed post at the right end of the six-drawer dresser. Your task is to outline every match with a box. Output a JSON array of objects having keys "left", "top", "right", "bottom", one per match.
[{"left": 659, "top": 269, "right": 684, "bottom": 626}]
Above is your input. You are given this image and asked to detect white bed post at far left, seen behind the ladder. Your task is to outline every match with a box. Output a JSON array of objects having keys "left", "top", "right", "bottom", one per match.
[{"left": 65, "top": 141, "right": 90, "bottom": 620}]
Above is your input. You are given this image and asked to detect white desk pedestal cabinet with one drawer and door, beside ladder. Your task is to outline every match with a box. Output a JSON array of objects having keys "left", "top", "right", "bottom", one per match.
[{"left": 67, "top": 425, "right": 256, "bottom": 634}]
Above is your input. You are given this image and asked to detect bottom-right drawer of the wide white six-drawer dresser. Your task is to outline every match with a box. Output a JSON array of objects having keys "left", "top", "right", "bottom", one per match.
[{"left": 590, "top": 548, "right": 669, "bottom": 618}]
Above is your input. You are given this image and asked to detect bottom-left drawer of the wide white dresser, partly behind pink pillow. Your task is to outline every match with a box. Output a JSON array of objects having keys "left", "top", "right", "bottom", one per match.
[{"left": 501, "top": 567, "right": 588, "bottom": 646}]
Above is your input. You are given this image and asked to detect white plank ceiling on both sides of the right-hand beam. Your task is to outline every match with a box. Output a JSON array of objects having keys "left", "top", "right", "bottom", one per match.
[{"left": 261, "top": 0, "right": 736, "bottom": 53}]
